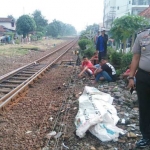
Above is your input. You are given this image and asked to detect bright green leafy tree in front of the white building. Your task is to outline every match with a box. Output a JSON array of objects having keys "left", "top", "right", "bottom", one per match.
[{"left": 110, "top": 15, "right": 148, "bottom": 51}]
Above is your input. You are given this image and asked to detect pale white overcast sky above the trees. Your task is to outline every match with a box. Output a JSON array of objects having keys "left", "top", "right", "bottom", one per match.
[{"left": 0, "top": 0, "right": 103, "bottom": 32}]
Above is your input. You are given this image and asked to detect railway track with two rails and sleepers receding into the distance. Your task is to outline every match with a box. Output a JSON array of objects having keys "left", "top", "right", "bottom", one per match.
[{"left": 0, "top": 39, "right": 77, "bottom": 110}]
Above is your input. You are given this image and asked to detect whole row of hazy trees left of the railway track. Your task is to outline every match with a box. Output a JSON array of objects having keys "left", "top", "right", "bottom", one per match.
[{"left": 13, "top": 10, "right": 77, "bottom": 40}]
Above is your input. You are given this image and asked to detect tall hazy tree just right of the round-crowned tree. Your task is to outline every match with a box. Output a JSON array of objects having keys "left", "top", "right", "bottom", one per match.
[{"left": 32, "top": 10, "right": 48, "bottom": 34}]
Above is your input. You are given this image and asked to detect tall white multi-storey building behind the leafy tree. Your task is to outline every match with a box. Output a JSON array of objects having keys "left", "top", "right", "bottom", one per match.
[{"left": 103, "top": 0, "right": 149, "bottom": 29}]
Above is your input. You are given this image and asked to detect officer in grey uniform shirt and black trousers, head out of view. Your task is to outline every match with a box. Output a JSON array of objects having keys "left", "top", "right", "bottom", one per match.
[{"left": 128, "top": 29, "right": 150, "bottom": 148}]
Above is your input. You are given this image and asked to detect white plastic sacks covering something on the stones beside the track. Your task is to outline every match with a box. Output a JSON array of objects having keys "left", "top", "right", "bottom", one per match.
[{"left": 75, "top": 86, "right": 124, "bottom": 142}]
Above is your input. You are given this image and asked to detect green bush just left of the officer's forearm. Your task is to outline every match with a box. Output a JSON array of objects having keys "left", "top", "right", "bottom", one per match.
[{"left": 121, "top": 52, "right": 133, "bottom": 67}]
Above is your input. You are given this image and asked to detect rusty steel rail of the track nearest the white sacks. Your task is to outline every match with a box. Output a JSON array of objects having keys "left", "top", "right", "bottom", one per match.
[{"left": 0, "top": 40, "right": 77, "bottom": 110}]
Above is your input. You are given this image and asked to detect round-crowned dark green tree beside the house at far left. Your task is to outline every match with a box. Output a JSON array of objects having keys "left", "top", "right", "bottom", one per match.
[{"left": 16, "top": 15, "right": 36, "bottom": 38}]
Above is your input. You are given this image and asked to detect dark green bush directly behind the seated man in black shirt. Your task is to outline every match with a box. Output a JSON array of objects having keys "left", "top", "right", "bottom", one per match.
[{"left": 110, "top": 51, "right": 122, "bottom": 66}]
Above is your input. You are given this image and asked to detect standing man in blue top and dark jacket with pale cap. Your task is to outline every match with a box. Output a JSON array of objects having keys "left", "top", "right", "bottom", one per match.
[{"left": 96, "top": 28, "right": 108, "bottom": 61}]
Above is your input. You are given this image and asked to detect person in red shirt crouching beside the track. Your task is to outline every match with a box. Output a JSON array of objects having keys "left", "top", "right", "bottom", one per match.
[{"left": 78, "top": 56, "right": 95, "bottom": 77}]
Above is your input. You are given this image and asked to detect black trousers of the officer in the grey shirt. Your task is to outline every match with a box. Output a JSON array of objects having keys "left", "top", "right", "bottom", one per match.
[{"left": 136, "top": 69, "right": 150, "bottom": 139}]
